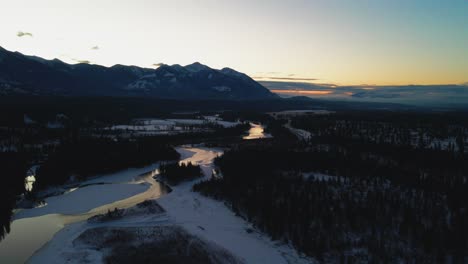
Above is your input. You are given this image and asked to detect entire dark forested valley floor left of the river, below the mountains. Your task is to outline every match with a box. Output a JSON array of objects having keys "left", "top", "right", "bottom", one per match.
[{"left": 0, "top": 103, "right": 250, "bottom": 240}]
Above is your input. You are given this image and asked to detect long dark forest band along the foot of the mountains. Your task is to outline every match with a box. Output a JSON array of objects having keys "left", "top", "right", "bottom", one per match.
[{"left": 0, "top": 96, "right": 428, "bottom": 126}]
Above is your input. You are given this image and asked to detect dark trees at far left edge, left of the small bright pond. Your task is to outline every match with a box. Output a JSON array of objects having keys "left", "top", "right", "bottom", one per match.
[{"left": 0, "top": 152, "right": 28, "bottom": 240}]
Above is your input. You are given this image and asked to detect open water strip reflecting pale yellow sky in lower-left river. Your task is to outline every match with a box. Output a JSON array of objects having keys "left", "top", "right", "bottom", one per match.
[{"left": 0, "top": 170, "right": 170, "bottom": 263}]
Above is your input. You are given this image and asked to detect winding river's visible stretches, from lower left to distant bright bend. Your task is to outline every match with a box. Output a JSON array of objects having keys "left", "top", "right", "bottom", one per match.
[{"left": 0, "top": 123, "right": 271, "bottom": 263}]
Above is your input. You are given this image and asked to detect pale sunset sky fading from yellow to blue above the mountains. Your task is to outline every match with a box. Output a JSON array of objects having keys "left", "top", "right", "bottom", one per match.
[{"left": 0, "top": 0, "right": 468, "bottom": 85}]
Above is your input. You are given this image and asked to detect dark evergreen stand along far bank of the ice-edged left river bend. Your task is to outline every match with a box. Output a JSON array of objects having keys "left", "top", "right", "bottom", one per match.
[{"left": 35, "top": 137, "right": 179, "bottom": 189}]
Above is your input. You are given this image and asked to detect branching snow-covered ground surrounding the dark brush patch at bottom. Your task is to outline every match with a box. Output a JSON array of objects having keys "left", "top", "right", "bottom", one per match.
[{"left": 27, "top": 147, "right": 313, "bottom": 264}]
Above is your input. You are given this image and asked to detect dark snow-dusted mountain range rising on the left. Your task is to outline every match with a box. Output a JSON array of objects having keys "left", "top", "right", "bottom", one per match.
[{"left": 0, "top": 47, "right": 278, "bottom": 100}]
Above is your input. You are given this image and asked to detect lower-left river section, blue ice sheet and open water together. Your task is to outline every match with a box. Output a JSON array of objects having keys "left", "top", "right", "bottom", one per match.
[{"left": 0, "top": 163, "right": 165, "bottom": 264}]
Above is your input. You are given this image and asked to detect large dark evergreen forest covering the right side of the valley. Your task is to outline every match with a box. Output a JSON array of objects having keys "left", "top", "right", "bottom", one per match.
[{"left": 194, "top": 111, "right": 468, "bottom": 263}]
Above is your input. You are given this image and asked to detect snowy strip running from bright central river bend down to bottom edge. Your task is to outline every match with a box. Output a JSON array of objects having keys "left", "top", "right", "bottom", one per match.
[{"left": 158, "top": 148, "right": 311, "bottom": 264}]
